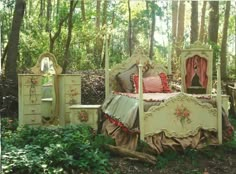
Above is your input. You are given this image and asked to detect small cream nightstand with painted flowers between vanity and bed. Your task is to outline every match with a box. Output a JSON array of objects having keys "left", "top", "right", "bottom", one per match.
[{"left": 70, "top": 105, "right": 101, "bottom": 130}]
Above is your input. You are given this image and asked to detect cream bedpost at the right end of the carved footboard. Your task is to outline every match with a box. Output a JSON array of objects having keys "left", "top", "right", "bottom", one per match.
[{"left": 217, "top": 63, "right": 222, "bottom": 144}]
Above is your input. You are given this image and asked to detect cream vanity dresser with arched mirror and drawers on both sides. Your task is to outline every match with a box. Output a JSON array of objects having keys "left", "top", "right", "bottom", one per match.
[{"left": 18, "top": 52, "right": 81, "bottom": 126}]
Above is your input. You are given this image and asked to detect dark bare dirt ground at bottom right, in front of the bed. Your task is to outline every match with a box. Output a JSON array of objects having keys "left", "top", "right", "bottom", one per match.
[{"left": 110, "top": 147, "right": 236, "bottom": 174}]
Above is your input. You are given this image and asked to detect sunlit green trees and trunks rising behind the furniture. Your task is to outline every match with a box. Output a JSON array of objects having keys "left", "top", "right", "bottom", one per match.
[{"left": 0, "top": 0, "right": 236, "bottom": 82}]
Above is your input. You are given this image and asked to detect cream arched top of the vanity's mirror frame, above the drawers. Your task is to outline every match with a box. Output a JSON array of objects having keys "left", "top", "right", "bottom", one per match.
[{"left": 31, "top": 52, "right": 62, "bottom": 74}]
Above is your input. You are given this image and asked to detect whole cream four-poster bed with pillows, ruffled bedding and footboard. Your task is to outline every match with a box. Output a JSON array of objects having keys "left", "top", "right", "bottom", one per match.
[{"left": 101, "top": 46, "right": 232, "bottom": 153}]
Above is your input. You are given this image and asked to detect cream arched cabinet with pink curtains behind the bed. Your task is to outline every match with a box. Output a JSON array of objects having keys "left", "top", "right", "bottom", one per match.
[{"left": 180, "top": 41, "right": 213, "bottom": 94}]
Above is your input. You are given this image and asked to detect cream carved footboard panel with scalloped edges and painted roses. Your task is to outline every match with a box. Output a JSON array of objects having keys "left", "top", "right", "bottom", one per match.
[{"left": 143, "top": 93, "right": 218, "bottom": 138}]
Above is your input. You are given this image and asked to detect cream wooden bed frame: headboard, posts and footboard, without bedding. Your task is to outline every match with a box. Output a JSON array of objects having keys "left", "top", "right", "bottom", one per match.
[{"left": 105, "top": 47, "right": 222, "bottom": 144}]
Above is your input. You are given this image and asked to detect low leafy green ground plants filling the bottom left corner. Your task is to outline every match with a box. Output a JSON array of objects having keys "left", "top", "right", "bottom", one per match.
[{"left": 2, "top": 125, "right": 111, "bottom": 174}]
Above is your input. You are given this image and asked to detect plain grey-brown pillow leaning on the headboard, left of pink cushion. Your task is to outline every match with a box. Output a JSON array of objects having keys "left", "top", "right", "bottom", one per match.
[{"left": 116, "top": 64, "right": 138, "bottom": 93}]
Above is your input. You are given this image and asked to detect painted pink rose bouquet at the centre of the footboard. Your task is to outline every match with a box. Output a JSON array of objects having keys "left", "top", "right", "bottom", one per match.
[{"left": 175, "top": 105, "right": 191, "bottom": 125}]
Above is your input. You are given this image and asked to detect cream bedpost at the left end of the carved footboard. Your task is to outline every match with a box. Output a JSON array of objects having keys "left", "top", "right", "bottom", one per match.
[{"left": 138, "top": 62, "right": 144, "bottom": 140}]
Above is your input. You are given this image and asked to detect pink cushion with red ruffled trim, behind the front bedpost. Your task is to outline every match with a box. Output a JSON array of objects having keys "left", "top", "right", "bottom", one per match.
[{"left": 133, "top": 73, "right": 171, "bottom": 93}]
